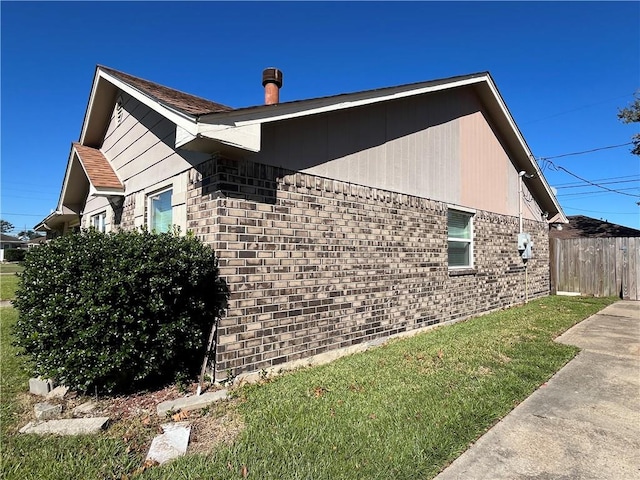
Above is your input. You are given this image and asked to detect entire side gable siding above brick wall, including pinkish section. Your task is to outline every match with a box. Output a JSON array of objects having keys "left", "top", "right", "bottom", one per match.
[{"left": 254, "top": 89, "right": 540, "bottom": 220}]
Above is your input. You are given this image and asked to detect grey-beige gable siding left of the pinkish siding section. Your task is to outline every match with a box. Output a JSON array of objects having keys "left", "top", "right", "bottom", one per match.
[{"left": 256, "top": 91, "right": 477, "bottom": 203}]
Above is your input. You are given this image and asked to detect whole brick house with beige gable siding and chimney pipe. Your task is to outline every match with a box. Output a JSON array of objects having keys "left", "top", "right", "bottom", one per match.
[{"left": 37, "top": 66, "right": 566, "bottom": 377}]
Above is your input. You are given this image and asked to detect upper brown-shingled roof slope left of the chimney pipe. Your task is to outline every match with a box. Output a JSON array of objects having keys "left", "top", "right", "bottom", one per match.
[{"left": 98, "top": 65, "right": 233, "bottom": 117}]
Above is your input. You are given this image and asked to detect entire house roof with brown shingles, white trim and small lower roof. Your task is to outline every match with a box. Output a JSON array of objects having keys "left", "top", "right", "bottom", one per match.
[{"left": 42, "top": 65, "right": 566, "bottom": 228}]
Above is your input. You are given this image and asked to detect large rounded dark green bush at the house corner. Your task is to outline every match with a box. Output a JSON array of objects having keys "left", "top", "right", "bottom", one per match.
[{"left": 14, "top": 229, "right": 227, "bottom": 392}]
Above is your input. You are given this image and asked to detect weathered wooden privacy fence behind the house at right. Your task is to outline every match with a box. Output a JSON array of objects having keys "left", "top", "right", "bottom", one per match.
[{"left": 549, "top": 237, "right": 640, "bottom": 300}]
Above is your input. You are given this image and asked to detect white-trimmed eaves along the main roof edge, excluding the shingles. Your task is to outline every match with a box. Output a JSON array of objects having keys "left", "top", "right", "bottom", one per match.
[{"left": 80, "top": 66, "right": 568, "bottom": 223}]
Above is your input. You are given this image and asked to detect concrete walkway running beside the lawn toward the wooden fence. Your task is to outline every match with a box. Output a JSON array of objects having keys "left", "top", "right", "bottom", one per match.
[{"left": 436, "top": 301, "right": 640, "bottom": 480}]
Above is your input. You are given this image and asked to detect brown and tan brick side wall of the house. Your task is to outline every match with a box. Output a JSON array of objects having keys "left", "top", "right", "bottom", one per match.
[{"left": 185, "top": 158, "right": 549, "bottom": 376}]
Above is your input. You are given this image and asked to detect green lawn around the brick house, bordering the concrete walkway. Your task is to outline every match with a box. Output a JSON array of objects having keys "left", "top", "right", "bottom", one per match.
[{"left": 0, "top": 297, "right": 615, "bottom": 479}]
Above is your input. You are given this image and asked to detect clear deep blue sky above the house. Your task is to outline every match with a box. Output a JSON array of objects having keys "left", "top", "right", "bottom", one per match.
[{"left": 0, "top": 1, "right": 640, "bottom": 233}]
